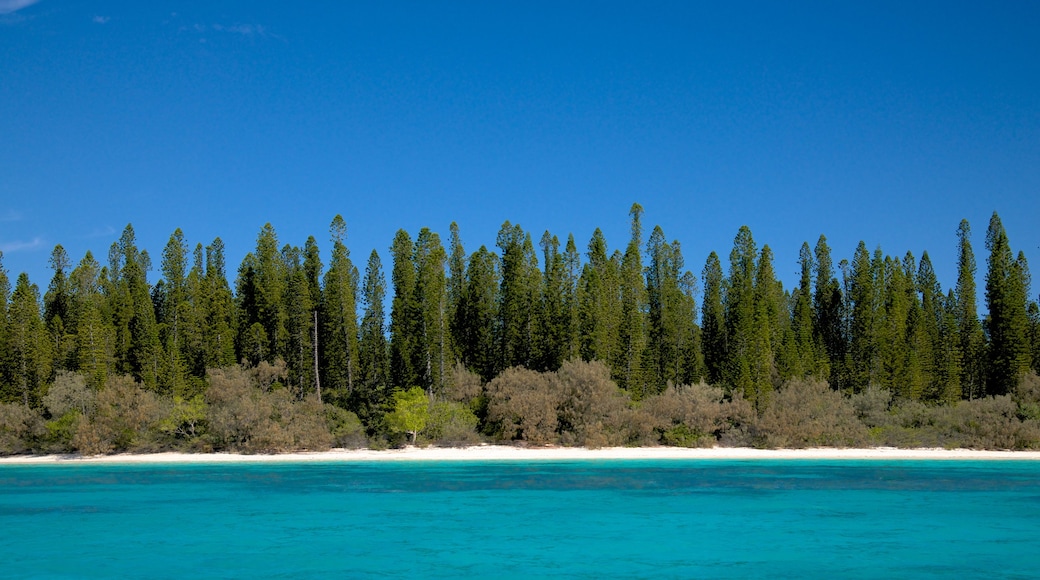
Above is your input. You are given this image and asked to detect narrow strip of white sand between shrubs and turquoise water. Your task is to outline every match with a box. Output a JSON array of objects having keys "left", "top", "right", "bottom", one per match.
[{"left": 0, "top": 445, "right": 1040, "bottom": 467}]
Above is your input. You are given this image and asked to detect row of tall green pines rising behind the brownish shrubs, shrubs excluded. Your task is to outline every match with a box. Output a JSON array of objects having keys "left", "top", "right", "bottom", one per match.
[{"left": 0, "top": 204, "right": 1040, "bottom": 422}]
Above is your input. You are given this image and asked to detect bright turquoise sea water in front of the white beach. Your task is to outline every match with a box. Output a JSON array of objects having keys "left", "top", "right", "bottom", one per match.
[{"left": 0, "top": 459, "right": 1040, "bottom": 579}]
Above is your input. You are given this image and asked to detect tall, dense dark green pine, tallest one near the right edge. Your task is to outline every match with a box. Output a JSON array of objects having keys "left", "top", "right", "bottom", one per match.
[{"left": 986, "top": 212, "right": 1029, "bottom": 395}]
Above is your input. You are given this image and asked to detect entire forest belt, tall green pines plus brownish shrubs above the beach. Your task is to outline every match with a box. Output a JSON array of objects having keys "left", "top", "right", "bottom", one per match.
[{"left": 0, "top": 204, "right": 1040, "bottom": 454}]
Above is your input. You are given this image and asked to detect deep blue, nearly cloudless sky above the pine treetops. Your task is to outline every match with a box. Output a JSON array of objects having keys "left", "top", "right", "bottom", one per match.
[{"left": 0, "top": 0, "right": 1040, "bottom": 296}]
